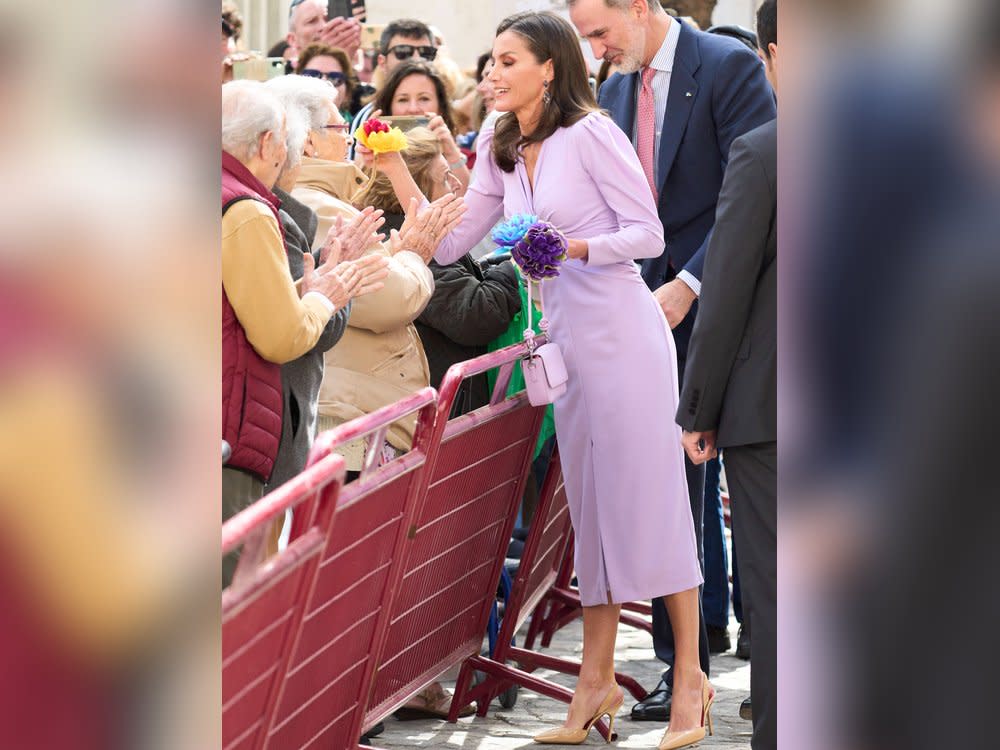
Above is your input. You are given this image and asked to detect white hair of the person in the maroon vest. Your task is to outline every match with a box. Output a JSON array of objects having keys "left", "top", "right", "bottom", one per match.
[{"left": 222, "top": 80, "right": 285, "bottom": 162}]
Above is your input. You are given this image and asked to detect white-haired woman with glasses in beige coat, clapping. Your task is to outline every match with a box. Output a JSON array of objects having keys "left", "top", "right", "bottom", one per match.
[{"left": 267, "top": 75, "right": 464, "bottom": 471}]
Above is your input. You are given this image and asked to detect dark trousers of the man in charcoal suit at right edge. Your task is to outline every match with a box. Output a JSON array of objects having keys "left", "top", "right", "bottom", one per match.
[{"left": 724, "top": 443, "right": 778, "bottom": 750}]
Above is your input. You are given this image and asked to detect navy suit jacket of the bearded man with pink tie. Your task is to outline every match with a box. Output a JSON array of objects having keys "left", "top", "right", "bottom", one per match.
[{"left": 599, "top": 19, "right": 777, "bottom": 365}]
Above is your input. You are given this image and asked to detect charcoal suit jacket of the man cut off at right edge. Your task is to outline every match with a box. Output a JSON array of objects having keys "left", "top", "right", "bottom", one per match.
[{"left": 677, "top": 120, "right": 778, "bottom": 448}]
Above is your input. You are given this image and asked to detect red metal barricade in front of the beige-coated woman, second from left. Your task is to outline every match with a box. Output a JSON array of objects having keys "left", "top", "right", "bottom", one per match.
[{"left": 266, "top": 388, "right": 436, "bottom": 750}]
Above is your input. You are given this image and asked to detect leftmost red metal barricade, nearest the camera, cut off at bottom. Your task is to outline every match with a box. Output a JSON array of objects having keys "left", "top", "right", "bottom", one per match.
[{"left": 222, "top": 456, "right": 344, "bottom": 750}]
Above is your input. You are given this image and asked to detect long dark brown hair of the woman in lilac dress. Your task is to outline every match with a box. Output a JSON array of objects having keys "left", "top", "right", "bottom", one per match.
[{"left": 493, "top": 11, "right": 600, "bottom": 172}]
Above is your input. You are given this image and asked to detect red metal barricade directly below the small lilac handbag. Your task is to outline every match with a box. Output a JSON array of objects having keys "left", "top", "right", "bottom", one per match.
[{"left": 364, "top": 344, "right": 544, "bottom": 728}]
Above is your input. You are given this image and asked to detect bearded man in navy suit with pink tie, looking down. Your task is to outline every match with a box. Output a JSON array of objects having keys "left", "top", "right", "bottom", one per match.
[{"left": 569, "top": 0, "right": 777, "bottom": 721}]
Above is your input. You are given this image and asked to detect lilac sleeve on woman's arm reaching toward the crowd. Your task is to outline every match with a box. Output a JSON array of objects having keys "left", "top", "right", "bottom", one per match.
[{"left": 434, "top": 128, "right": 503, "bottom": 266}]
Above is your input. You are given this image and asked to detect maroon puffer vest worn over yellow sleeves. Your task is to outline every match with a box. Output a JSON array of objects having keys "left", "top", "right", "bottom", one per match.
[{"left": 222, "top": 151, "right": 284, "bottom": 482}]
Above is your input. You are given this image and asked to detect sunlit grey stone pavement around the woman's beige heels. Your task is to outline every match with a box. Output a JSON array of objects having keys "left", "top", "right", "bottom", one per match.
[{"left": 371, "top": 620, "right": 751, "bottom": 750}]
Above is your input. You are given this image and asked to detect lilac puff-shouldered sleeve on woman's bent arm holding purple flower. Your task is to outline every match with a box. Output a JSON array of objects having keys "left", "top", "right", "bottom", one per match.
[{"left": 574, "top": 115, "right": 663, "bottom": 265}]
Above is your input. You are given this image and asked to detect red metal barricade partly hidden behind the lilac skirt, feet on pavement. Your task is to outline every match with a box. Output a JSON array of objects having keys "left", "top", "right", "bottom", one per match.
[{"left": 448, "top": 447, "right": 646, "bottom": 739}]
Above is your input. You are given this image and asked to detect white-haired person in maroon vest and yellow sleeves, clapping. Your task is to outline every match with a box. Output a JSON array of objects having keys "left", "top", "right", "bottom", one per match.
[{"left": 222, "top": 81, "right": 386, "bottom": 580}]
